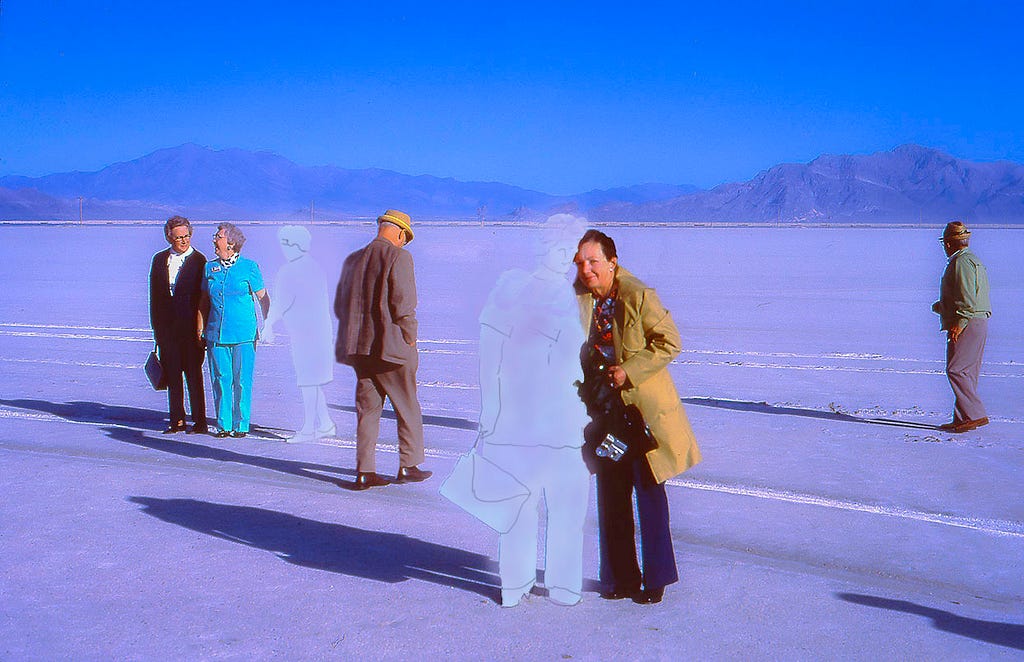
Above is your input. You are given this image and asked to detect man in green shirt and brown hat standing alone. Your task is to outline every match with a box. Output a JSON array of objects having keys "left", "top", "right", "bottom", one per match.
[{"left": 932, "top": 220, "right": 992, "bottom": 432}]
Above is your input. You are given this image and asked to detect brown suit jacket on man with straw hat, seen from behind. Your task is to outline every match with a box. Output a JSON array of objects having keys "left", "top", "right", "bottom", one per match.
[{"left": 334, "top": 237, "right": 417, "bottom": 366}]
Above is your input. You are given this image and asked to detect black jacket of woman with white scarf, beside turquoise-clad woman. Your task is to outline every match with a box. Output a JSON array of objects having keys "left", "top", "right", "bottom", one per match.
[{"left": 150, "top": 248, "right": 206, "bottom": 344}]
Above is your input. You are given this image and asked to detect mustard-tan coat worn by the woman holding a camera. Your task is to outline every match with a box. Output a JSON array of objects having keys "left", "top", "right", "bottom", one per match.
[{"left": 577, "top": 266, "right": 700, "bottom": 483}]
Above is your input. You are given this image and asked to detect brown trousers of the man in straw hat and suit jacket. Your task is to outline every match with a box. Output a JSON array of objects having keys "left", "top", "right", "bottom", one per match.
[{"left": 353, "top": 355, "right": 424, "bottom": 472}]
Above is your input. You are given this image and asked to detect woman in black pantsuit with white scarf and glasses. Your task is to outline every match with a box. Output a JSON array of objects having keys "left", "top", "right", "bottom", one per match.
[{"left": 150, "top": 216, "right": 207, "bottom": 435}]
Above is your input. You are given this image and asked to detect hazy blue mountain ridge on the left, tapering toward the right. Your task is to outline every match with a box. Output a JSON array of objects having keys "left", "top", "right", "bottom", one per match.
[{"left": 0, "top": 144, "right": 696, "bottom": 220}]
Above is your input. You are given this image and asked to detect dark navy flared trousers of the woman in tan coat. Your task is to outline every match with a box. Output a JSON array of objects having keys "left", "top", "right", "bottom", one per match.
[{"left": 597, "top": 456, "right": 679, "bottom": 592}]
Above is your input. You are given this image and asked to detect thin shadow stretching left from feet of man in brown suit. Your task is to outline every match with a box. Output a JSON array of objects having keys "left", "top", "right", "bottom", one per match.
[{"left": 101, "top": 427, "right": 355, "bottom": 488}]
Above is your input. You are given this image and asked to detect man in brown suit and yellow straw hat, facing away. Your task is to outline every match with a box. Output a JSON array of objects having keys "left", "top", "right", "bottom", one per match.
[{"left": 334, "top": 209, "right": 431, "bottom": 490}]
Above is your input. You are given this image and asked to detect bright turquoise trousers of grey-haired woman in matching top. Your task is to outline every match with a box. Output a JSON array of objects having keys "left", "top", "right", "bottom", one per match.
[{"left": 209, "top": 342, "right": 256, "bottom": 432}]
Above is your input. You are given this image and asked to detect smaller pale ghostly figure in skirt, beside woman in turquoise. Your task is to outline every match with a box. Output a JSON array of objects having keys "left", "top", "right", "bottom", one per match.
[{"left": 263, "top": 225, "right": 337, "bottom": 442}]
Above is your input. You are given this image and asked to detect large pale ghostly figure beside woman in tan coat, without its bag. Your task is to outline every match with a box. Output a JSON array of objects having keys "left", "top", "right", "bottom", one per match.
[{"left": 479, "top": 214, "right": 590, "bottom": 607}]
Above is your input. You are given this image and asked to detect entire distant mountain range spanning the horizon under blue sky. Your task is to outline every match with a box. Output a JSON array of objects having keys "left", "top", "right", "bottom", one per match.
[{"left": 0, "top": 144, "right": 1024, "bottom": 223}]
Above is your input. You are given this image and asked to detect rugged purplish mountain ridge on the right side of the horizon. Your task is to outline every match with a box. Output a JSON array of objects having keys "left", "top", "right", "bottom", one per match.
[{"left": 590, "top": 144, "right": 1024, "bottom": 223}]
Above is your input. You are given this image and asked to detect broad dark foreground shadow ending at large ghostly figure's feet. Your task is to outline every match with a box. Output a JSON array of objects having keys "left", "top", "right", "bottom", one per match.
[{"left": 129, "top": 496, "right": 500, "bottom": 602}]
